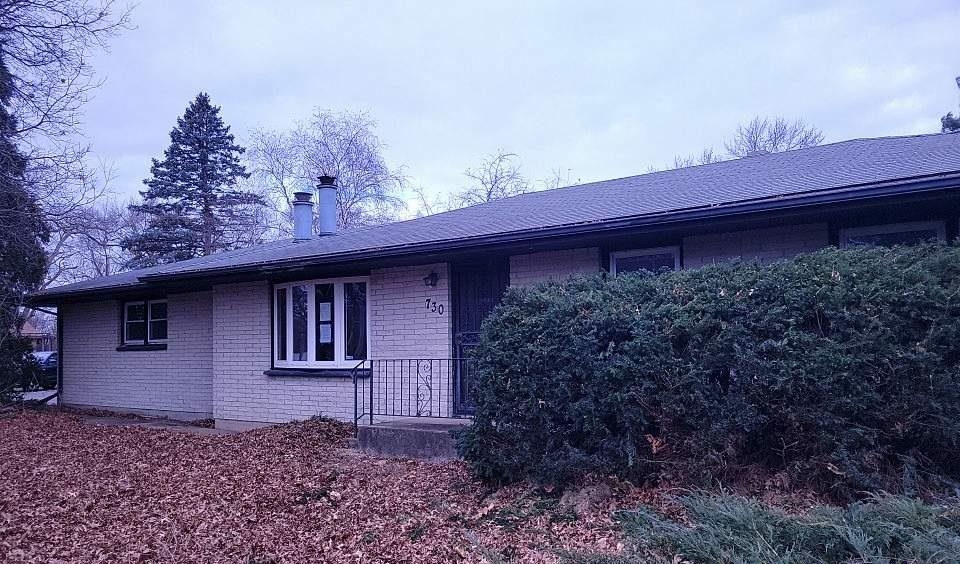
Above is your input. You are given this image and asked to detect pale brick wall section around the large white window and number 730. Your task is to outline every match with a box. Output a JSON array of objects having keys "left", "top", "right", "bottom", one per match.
[{"left": 213, "top": 264, "right": 450, "bottom": 427}]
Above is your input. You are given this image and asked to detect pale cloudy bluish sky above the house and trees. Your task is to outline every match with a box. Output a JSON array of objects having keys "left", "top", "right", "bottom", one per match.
[{"left": 85, "top": 0, "right": 960, "bottom": 207}]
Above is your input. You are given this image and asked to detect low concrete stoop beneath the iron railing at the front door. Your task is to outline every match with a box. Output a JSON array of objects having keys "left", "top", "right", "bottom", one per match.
[{"left": 357, "top": 419, "right": 469, "bottom": 461}]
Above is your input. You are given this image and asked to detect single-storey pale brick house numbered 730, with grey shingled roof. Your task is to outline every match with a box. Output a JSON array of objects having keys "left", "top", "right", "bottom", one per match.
[{"left": 26, "top": 134, "right": 960, "bottom": 428}]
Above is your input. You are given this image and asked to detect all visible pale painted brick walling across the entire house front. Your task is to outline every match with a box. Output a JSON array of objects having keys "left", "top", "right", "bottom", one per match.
[{"left": 62, "top": 224, "right": 828, "bottom": 427}]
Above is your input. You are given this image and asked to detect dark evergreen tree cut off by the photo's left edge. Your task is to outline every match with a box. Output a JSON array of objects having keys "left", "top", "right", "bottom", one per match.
[{"left": 0, "top": 49, "right": 49, "bottom": 403}]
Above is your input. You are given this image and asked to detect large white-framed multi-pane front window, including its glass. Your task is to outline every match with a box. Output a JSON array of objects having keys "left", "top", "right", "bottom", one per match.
[{"left": 273, "top": 278, "right": 369, "bottom": 368}]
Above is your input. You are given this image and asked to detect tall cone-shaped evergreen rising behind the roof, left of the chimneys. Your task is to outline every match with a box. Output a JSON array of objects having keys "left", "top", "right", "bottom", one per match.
[{"left": 123, "top": 92, "right": 263, "bottom": 268}]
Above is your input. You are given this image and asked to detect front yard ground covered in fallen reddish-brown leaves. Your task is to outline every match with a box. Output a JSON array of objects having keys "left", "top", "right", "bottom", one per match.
[{"left": 0, "top": 412, "right": 645, "bottom": 564}]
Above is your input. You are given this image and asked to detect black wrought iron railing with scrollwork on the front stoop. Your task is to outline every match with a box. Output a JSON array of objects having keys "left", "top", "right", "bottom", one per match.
[{"left": 353, "top": 358, "right": 476, "bottom": 425}]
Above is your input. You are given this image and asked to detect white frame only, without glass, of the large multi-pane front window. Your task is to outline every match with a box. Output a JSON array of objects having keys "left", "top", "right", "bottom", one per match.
[{"left": 271, "top": 276, "right": 370, "bottom": 368}]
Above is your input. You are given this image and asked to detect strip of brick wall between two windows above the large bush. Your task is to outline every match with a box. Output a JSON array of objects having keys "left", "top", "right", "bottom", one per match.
[{"left": 683, "top": 223, "right": 829, "bottom": 268}]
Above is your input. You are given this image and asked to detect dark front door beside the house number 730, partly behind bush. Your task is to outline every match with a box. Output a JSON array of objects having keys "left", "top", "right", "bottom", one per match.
[{"left": 451, "top": 258, "right": 510, "bottom": 415}]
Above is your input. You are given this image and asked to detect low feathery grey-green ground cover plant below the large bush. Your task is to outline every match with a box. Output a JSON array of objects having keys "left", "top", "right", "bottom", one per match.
[{"left": 570, "top": 494, "right": 960, "bottom": 564}]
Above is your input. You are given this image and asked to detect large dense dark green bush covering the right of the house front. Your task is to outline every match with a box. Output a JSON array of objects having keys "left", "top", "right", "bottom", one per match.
[{"left": 460, "top": 246, "right": 960, "bottom": 496}]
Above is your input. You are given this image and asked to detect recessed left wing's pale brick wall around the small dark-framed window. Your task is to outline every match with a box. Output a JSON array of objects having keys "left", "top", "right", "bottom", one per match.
[{"left": 61, "top": 292, "right": 213, "bottom": 418}]
